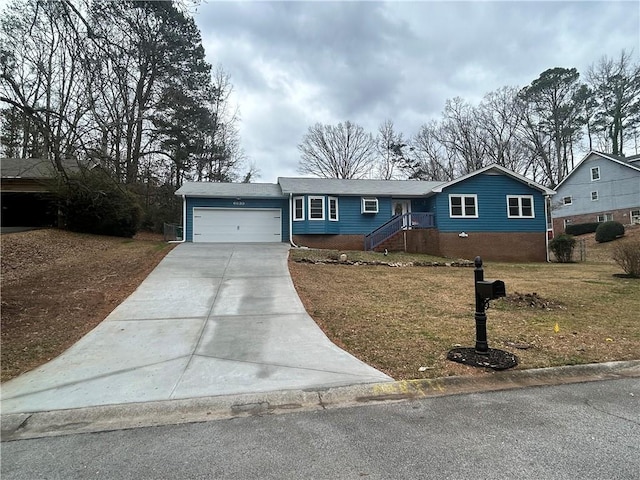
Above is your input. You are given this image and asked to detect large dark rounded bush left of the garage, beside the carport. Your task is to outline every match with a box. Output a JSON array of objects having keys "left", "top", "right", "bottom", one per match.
[{"left": 57, "top": 171, "right": 142, "bottom": 237}]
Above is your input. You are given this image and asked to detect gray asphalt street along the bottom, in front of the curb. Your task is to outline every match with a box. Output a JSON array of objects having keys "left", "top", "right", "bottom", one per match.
[{"left": 0, "top": 378, "right": 640, "bottom": 480}]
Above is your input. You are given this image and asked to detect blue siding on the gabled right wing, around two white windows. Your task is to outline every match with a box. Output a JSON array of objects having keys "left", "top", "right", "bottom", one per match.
[{"left": 434, "top": 173, "right": 546, "bottom": 233}]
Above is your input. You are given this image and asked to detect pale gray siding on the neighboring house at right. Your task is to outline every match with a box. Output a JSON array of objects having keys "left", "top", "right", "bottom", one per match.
[{"left": 552, "top": 154, "right": 640, "bottom": 221}]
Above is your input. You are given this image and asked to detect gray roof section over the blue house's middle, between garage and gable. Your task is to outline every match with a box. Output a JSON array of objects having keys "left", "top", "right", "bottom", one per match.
[{"left": 278, "top": 177, "right": 442, "bottom": 197}]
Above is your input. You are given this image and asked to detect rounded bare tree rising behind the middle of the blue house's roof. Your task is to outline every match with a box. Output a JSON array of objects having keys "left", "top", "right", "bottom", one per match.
[{"left": 298, "top": 121, "right": 375, "bottom": 178}]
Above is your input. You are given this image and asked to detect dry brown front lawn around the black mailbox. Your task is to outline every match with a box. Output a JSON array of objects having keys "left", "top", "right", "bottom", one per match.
[{"left": 289, "top": 250, "right": 640, "bottom": 380}]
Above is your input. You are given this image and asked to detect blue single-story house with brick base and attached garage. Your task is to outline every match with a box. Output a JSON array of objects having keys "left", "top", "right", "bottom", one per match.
[{"left": 176, "top": 165, "right": 555, "bottom": 261}]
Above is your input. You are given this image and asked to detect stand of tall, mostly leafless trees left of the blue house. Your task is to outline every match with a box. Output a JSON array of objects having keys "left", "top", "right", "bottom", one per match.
[{"left": 0, "top": 0, "right": 250, "bottom": 187}]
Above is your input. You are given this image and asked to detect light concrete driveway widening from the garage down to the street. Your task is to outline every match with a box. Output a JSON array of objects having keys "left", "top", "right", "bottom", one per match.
[{"left": 1, "top": 243, "right": 392, "bottom": 414}]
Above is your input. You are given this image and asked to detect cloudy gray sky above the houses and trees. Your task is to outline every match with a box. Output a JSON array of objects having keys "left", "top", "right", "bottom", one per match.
[{"left": 194, "top": 0, "right": 640, "bottom": 182}]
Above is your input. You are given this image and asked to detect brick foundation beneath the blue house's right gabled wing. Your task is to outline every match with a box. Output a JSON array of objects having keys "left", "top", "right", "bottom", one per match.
[{"left": 440, "top": 232, "right": 547, "bottom": 262}]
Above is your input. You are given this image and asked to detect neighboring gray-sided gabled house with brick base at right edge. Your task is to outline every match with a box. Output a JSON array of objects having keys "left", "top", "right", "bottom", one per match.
[{"left": 551, "top": 151, "right": 640, "bottom": 234}]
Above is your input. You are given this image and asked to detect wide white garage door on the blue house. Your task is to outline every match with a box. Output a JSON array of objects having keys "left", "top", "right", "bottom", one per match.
[{"left": 193, "top": 208, "right": 282, "bottom": 243}]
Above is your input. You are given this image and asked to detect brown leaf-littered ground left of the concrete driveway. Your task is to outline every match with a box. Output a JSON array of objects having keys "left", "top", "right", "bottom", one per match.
[{"left": 0, "top": 229, "right": 172, "bottom": 381}]
